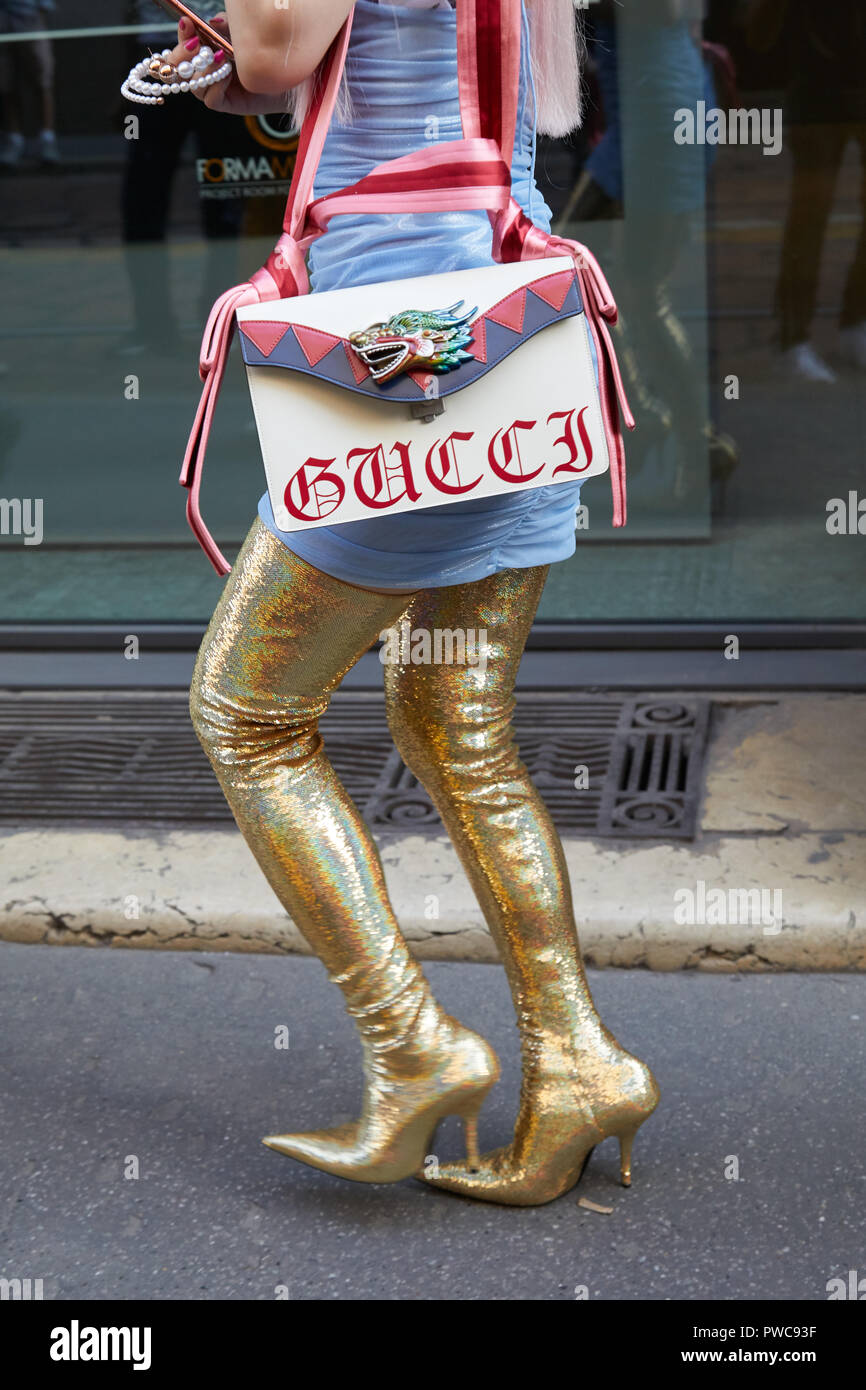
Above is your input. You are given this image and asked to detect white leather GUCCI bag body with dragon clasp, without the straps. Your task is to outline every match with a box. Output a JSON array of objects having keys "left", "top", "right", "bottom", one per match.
[{"left": 236, "top": 256, "right": 609, "bottom": 531}]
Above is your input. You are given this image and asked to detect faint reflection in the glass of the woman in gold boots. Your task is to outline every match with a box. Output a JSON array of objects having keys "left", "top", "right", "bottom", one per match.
[{"left": 570, "top": 0, "right": 737, "bottom": 496}]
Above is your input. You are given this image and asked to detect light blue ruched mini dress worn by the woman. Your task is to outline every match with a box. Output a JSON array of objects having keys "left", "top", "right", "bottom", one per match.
[{"left": 259, "top": 0, "right": 581, "bottom": 591}]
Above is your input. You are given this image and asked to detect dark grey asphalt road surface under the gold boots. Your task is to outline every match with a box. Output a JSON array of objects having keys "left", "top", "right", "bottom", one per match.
[{"left": 0, "top": 944, "right": 866, "bottom": 1301}]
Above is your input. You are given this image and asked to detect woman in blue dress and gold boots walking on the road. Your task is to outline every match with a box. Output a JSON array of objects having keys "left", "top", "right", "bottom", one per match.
[{"left": 167, "top": 0, "right": 657, "bottom": 1205}]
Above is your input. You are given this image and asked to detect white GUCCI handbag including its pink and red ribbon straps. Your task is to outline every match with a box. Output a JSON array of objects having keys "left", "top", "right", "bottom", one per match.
[{"left": 181, "top": 0, "right": 634, "bottom": 574}]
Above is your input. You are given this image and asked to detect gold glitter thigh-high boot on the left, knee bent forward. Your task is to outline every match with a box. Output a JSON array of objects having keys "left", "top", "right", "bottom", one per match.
[{"left": 190, "top": 520, "right": 499, "bottom": 1183}]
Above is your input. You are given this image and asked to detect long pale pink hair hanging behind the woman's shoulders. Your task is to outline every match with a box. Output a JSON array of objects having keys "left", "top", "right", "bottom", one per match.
[{"left": 286, "top": 0, "right": 584, "bottom": 135}]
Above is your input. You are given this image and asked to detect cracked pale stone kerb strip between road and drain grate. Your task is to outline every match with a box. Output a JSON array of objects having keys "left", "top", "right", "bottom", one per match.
[{"left": 0, "top": 827, "right": 866, "bottom": 972}]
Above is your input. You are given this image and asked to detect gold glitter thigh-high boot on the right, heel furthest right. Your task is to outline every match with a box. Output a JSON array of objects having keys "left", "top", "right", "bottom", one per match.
[{"left": 385, "top": 567, "right": 659, "bottom": 1205}]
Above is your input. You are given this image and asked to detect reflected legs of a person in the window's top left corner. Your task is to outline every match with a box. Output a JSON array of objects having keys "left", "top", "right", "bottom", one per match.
[{"left": 0, "top": 0, "right": 60, "bottom": 165}]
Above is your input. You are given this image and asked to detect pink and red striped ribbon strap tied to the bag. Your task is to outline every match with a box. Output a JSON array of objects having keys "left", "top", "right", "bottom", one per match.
[{"left": 179, "top": 0, "right": 634, "bottom": 574}]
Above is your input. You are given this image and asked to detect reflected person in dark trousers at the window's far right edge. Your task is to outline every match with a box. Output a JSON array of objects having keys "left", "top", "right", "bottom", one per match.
[{"left": 748, "top": 0, "right": 866, "bottom": 382}]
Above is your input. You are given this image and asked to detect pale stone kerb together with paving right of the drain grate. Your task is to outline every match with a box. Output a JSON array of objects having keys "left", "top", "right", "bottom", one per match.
[{"left": 0, "top": 692, "right": 866, "bottom": 972}]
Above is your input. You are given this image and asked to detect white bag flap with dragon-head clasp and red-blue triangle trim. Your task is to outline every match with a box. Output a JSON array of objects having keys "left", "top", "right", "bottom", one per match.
[{"left": 238, "top": 256, "right": 582, "bottom": 402}]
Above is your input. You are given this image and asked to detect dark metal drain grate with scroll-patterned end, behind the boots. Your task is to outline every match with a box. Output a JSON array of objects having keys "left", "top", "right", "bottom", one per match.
[{"left": 0, "top": 691, "right": 709, "bottom": 838}]
